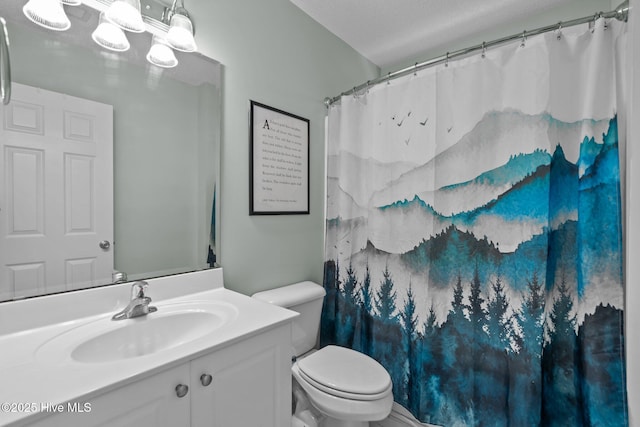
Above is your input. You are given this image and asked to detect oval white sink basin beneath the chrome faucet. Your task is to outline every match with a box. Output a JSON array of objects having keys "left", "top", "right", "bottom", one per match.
[{"left": 36, "top": 301, "right": 237, "bottom": 363}]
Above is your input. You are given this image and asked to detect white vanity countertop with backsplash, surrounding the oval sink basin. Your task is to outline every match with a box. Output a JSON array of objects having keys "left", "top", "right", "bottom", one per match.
[{"left": 0, "top": 271, "right": 297, "bottom": 426}]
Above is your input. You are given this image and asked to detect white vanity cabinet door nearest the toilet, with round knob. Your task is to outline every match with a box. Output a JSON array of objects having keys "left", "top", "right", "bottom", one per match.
[{"left": 191, "top": 324, "right": 291, "bottom": 427}]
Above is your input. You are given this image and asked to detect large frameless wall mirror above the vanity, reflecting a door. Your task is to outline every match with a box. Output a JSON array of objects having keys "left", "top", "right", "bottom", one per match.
[{"left": 0, "top": 0, "right": 221, "bottom": 301}]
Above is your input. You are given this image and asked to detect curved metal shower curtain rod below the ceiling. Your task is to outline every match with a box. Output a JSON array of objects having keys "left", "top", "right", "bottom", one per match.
[{"left": 324, "top": 0, "right": 629, "bottom": 108}]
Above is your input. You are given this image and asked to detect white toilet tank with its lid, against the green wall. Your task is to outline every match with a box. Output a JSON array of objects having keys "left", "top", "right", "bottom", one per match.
[{"left": 253, "top": 281, "right": 326, "bottom": 356}]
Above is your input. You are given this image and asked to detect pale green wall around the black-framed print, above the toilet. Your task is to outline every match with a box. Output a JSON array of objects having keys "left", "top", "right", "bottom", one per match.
[{"left": 190, "top": 0, "right": 378, "bottom": 295}]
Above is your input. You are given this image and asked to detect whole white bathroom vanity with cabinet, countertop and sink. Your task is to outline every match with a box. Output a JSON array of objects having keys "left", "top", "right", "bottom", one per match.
[{"left": 0, "top": 269, "right": 296, "bottom": 427}]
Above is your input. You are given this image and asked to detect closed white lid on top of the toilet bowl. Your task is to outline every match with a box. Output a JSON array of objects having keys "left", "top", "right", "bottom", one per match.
[{"left": 297, "top": 345, "right": 391, "bottom": 395}]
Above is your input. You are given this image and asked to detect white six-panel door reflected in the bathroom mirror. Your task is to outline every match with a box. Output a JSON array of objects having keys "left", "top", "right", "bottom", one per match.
[{"left": 0, "top": 83, "right": 113, "bottom": 301}]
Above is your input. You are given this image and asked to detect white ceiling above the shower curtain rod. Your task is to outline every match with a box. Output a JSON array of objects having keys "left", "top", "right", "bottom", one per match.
[{"left": 291, "top": 0, "right": 592, "bottom": 69}]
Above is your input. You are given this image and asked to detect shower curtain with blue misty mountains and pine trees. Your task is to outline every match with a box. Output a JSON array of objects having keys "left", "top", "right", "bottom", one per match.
[{"left": 321, "top": 19, "right": 628, "bottom": 427}]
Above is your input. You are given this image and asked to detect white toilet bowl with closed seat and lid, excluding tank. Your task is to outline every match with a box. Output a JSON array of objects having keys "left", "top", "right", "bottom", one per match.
[{"left": 291, "top": 345, "right": 393, "bottom": 427}]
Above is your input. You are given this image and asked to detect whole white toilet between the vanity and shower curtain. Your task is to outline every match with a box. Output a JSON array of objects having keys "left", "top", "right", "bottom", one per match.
[{"left": 253, "top": 282, "right": 393, "bottom": 427}]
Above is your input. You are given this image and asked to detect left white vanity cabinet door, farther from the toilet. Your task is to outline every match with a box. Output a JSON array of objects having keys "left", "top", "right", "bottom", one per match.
[{"left": 25, "top": 363, "right": 191, "bottom": 427}]
